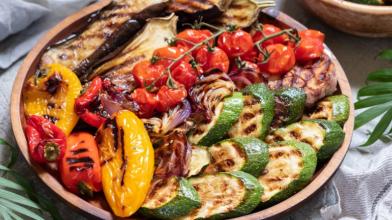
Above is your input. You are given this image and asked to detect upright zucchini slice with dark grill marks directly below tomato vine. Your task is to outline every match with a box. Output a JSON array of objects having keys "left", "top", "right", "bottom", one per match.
[{"left": 228, "top": 84, "right": 275, "bottom": 139}]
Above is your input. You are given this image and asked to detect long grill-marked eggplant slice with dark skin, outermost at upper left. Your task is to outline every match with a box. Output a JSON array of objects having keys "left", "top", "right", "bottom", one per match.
[{"left": 40, "top": 0, "right": 168, "bottom": 76}]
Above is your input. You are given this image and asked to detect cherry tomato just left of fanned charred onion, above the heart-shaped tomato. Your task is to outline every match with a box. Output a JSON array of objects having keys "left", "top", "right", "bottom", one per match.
[{"left": 172, "top": 61, "right": 199, "bottom": 89}]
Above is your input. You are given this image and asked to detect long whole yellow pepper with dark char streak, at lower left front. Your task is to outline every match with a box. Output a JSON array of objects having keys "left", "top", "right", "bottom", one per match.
[{"left": 96, "top": 110, "right": 154, "bottom": 217}]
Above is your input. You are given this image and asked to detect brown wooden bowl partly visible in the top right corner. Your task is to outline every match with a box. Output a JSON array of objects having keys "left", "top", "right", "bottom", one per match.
[{"left": 301, "top": 0, "right": 392, "bottom": 37}]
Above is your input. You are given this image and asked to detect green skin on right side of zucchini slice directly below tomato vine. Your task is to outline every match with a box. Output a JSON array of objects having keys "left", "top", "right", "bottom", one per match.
[{"left": 242, "top": 83, "right": 275, "bottom": 139}]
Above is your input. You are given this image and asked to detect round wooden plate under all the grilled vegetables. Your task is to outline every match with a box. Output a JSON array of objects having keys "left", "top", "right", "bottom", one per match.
[{"left": 11, "top": 0, "right": 354, "bottom": 219}]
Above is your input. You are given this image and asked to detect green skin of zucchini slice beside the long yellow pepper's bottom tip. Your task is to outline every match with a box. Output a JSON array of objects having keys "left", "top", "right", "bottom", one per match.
[{"left": 139, "top": 177, "right": 201, "bottom": 219}]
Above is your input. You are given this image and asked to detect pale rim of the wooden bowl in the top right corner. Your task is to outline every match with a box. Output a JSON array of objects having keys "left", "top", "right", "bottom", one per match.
[{"left": 319, "top": 0, "right": 392, "bottom": 15}]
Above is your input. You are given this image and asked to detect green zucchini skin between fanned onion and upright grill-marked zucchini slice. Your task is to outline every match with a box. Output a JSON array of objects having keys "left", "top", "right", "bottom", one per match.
[{"left": 194, "top": 92, "right": 244, "bottom": 146}]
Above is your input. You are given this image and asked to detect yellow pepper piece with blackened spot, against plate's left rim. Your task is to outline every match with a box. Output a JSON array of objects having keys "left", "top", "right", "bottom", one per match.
[{"left": 23, "top": 64, "right": 82, "bottom": 136}]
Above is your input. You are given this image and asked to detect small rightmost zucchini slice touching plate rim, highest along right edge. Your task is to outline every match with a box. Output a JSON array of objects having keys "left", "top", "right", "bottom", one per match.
[{"left": 309, "top": 95, "right": 350, "bottom": 126}]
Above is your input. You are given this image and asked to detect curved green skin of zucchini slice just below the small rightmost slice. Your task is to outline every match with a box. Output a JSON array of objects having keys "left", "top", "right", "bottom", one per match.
[{"left": 310, "top": 119, "right": 345, "bottom": 161}]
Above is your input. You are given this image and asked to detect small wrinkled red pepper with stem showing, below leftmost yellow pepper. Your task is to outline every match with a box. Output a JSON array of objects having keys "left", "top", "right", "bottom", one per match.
[{"left": 25, "top": 115, "right": 66, "bottom": 164}]
